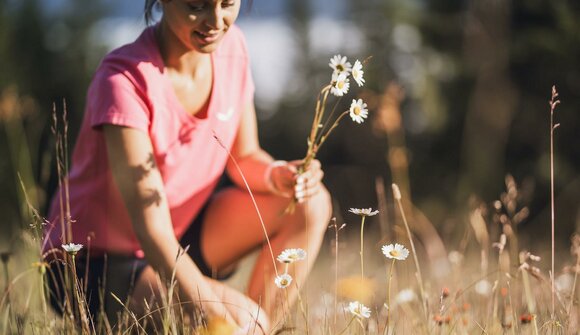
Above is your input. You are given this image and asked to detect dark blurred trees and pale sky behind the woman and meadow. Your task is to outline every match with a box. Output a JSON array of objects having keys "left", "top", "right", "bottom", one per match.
[{"left": 0, "top": 0, "right": 580, "bottom": 258}]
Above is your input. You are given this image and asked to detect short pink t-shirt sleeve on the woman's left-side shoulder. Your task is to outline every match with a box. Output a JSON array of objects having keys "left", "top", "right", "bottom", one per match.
[{"left": 87, "top": 68, "right": 150, "bottom": 132}]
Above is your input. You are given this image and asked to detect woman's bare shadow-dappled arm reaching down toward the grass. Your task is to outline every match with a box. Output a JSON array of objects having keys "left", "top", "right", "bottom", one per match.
[{"left": 103, "top": 125, "right": 236, "bottom": 326}]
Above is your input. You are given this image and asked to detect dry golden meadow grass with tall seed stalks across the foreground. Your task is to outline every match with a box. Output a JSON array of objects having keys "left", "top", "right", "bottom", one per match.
[{"left": 0, "top": 83, "right": 580, "bottom": 334}]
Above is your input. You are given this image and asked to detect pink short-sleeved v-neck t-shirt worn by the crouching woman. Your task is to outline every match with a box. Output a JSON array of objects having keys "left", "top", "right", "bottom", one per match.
[{"left": 47, "top": 26, "right": 254, "bottom": 257}]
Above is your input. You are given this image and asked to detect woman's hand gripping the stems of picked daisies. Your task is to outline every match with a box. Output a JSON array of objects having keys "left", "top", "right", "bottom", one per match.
[{"left": 268, "top": 159, "right": 324, "bottom": 203}]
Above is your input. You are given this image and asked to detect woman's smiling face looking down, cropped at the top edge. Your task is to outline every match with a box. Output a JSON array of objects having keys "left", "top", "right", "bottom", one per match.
[{"left": 162, "top": 0, "right": 241, "bottom": 53}]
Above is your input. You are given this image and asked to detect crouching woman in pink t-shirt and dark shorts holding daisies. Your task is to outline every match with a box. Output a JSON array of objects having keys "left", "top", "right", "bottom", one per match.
[{"left": 49, "top": 0, "right": 331, "bottom": 331}]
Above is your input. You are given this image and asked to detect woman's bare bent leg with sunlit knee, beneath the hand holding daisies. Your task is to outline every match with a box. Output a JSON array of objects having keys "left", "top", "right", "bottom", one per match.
[{"left": 201, "top": 188, "right": 331, "bottom": 324}]
